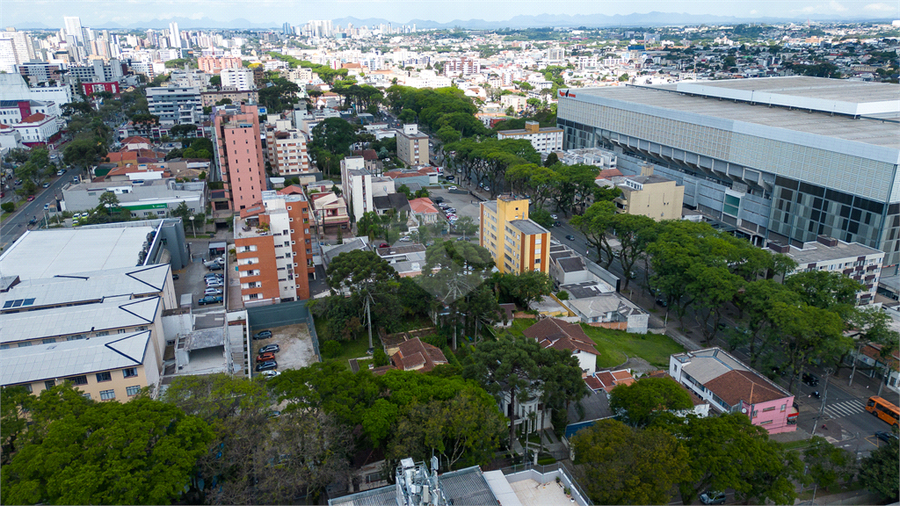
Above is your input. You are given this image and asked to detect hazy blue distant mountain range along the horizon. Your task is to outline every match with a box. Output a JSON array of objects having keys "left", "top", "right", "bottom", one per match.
[{"left": 8, "top": 12, "right": 891, "bottom": 30}]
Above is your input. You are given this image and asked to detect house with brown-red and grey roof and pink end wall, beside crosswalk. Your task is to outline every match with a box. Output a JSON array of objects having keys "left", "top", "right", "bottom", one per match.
[{"left": 669, "top": 348, "right": 797, "bottom": 434}]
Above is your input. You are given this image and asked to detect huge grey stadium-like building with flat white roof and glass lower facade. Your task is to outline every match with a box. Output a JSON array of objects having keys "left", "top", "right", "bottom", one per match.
[{"left": 558, "top": 77, "right": 900, "bottom": 266}]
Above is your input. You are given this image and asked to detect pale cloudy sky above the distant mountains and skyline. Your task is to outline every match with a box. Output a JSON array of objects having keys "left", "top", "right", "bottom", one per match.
[{"left": 0, "top": 0, "right": 900, "bottom": 27}]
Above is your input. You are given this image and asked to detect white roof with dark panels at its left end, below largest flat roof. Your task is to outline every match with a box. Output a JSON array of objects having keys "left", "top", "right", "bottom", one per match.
[{"left": 0, "top": 264, "right": 171, "bottom": 312}]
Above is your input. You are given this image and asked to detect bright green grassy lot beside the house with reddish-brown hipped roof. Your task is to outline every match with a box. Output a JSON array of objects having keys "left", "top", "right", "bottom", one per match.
[{"left": 509, "top": 319, "right": 684, "bottom": 369}]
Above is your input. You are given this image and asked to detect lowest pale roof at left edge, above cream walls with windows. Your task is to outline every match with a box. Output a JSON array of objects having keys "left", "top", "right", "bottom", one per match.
[{"left": 0, "top": 330, "right": 150, "bottom": 385}]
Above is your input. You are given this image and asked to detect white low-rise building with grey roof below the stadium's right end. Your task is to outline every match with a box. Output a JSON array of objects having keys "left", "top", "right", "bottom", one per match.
[{"left": 769, "top": 236, "right": 884, "bottom": 304}]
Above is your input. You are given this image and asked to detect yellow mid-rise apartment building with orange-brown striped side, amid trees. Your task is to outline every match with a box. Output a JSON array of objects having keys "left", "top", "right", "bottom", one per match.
[{"left": 478, "top": 195, "right": 550, "bottom": 274}]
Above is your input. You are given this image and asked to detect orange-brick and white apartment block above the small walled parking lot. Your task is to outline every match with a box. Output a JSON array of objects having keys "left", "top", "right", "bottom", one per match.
[{"left": 234, "top": 187, "right": 316, "bottom": 306}]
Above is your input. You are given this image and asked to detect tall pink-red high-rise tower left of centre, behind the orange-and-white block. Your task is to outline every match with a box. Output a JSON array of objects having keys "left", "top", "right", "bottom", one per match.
[{"left": 213, "top": 105, "right": 266, "bottom": 211}]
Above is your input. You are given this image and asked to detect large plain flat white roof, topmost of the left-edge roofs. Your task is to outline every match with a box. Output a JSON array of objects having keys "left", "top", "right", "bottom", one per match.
[{"left": 0, "top": 227, "right": 154, "bottom": 280}]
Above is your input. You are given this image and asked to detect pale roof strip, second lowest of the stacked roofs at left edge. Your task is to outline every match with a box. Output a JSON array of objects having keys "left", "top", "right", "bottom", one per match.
[{"left": 0, "top": 295, "right": 162, "bottom": 344}]
